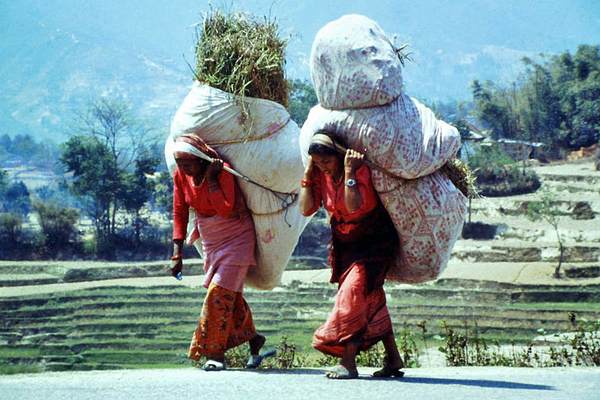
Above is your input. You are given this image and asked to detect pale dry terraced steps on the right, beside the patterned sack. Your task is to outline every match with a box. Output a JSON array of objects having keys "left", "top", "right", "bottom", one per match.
[{"left": 446, "top": 160, "right": 600, "bottom": 283}]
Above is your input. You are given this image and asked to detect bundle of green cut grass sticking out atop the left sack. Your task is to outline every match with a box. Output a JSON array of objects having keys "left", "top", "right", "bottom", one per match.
[{"left": 195, "top": 11, "right": 288, "bottom": 107}]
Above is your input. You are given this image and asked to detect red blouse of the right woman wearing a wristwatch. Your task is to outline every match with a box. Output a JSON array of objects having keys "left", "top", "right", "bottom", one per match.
[{"left": 307, "top": 164, "right": 378, "bottom": 222}]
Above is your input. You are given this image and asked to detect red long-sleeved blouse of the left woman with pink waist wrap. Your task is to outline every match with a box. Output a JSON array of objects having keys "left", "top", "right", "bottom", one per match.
[{"left": 173, "top": 163, "right": 243, "bottom": 240}]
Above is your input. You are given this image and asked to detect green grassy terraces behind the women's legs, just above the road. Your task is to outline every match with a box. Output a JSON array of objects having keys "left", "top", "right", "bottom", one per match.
[{"left": 0, "top": 282, "right": 600, "bottom": 373}]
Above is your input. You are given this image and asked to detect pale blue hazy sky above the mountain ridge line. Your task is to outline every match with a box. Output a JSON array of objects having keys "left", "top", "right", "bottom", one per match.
[{"left": 0, "top": 0, "right": 600, "bottom": 65}]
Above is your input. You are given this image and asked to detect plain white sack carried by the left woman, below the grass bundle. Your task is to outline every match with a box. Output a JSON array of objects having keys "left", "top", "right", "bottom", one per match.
[{"left": 165, "top": 82, "right": 307, "bottom": 289}]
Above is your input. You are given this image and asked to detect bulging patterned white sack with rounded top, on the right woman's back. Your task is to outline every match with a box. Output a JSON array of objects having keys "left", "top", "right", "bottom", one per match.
[{"left": 300, "top": 15, "right": 466, "bottom": 283}]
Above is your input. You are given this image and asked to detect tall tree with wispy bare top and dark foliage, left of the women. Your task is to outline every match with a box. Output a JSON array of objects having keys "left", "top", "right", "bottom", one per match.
[{"left": 61, "top": 99, "right": 158, "bottom": 257}]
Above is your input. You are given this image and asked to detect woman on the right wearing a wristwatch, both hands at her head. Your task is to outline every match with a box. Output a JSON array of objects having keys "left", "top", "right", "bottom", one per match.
[{"left": 300, "top": 132, "right": 404, "bottom": 379}]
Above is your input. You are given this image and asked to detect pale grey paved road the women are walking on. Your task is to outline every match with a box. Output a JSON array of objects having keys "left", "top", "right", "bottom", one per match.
[{"left": 0, "top": 367, "right": 600, "bottom": 400}]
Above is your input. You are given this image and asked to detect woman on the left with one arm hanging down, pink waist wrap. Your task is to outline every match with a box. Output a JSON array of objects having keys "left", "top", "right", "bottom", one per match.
[{"left": 171, "top": 135, "right": 272, "bottom": 371}]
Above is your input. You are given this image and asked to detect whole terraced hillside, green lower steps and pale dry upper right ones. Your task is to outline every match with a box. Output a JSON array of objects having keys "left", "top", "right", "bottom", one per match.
[{"left": 0, "top": 163, "right": 600, "bottom": 373}]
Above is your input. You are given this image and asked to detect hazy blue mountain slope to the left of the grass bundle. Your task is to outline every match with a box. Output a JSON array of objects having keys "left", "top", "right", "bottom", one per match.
[{"left": 0, "top": 11, "right": 191, "bottom": 142}]
